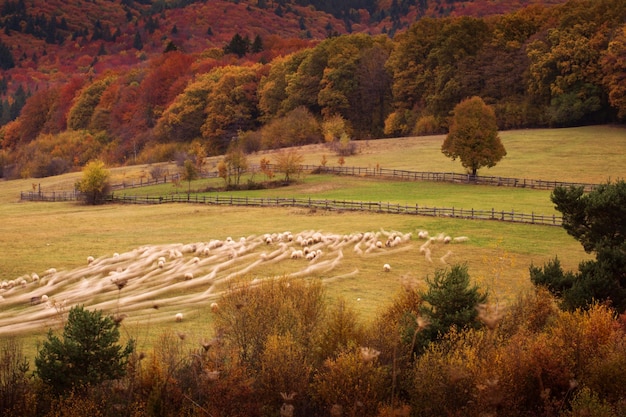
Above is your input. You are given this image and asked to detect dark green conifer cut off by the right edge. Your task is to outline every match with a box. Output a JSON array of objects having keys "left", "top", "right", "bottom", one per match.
[{"left": 530, "top": 180, "right": 626, "bottom": 313}]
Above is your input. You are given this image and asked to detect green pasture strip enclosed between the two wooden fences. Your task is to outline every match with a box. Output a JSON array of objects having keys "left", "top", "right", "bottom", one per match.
[{"left": 127, "top": 174, "right": 558, "bottom": 215}]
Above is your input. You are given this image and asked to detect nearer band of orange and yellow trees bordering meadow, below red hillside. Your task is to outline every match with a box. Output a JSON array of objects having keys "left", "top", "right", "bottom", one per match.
[{"left": 0, "top": 0, "right": 626, "bottom": 177}]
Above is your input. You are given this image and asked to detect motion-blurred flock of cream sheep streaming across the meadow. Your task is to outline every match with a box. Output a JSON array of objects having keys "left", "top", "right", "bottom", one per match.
[{"left": 0, "top": 230, "right": 467, "bottom": 334}]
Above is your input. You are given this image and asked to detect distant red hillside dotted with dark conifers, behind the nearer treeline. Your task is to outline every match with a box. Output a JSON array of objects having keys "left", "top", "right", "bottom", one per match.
[{"left": 0, "top": 0, "right": 564, "bottom": 96}]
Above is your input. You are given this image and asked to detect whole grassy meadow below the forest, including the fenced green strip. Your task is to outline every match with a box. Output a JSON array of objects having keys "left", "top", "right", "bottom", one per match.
[{"left": 0, "top": 126, "right": 626, "bottom": 356}]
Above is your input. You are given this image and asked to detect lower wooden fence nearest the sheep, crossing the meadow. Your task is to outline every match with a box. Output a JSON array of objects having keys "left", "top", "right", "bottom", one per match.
[{"left": 110, "top": 194, "right": 563, "bottom": 226}]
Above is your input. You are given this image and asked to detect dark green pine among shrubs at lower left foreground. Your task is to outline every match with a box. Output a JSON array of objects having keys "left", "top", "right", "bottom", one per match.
[{"left": 35, "top": 306, "right": 135, "bottom": 394}]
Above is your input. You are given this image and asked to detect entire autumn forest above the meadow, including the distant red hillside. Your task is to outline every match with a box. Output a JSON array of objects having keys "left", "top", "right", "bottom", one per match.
[{"left": 0, "top": 0, "right": 626, "bottom": 178}]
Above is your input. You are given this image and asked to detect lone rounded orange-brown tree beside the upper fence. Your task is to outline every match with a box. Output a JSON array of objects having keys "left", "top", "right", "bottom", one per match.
[{"left": 441, "top": 97, "right": 506, "bottom": 176}]
